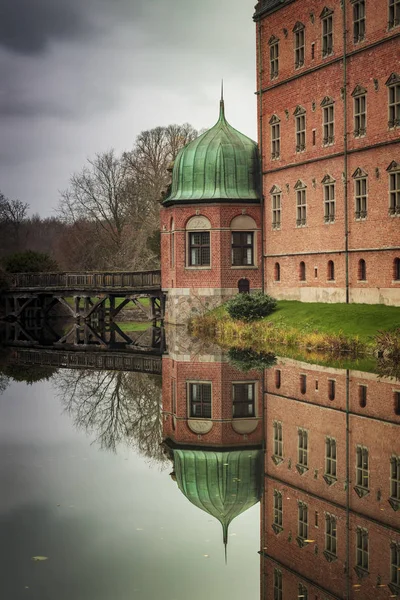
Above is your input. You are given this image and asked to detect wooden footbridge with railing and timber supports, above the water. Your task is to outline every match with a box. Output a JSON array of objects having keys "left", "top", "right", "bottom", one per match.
[{"left": 5, "top": 271, "right": 165, "bottom": 321}]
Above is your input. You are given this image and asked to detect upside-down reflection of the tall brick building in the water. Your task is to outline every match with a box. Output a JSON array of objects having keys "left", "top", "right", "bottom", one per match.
[{"left": 261, "top": 359, "right": 400, "bottom": 600}]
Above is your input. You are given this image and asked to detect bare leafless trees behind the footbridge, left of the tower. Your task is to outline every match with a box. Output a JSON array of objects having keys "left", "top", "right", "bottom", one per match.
[{"left": 0, "top": 123, "right": 198, "bottom": 270}]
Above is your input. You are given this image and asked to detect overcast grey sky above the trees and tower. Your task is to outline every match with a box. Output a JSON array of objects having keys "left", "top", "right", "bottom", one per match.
[{"left": 0, "top": 0, "right": 256, "bottom": 216}]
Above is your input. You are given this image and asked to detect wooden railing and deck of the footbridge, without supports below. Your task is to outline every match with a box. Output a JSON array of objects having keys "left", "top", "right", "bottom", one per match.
[{"left": 9, "top": 271, "right": 161, "bottom": 295}]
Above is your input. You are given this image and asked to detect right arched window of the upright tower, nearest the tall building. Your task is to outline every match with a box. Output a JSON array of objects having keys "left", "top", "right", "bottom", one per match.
[{"left": 231, "top": 215, "right": 257, "bottom": 267}]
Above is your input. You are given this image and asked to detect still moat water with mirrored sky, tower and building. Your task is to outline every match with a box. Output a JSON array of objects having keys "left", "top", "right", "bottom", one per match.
[{"left": 0, "top": 331, "right": 400, "bottom": 600}]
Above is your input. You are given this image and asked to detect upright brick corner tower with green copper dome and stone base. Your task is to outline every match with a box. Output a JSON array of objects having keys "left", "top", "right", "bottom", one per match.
[{"left": 161, "top": 99, "right": 262, "bottom": 323}]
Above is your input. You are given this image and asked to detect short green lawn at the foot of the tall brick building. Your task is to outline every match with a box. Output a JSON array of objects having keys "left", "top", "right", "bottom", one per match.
[{"left": 262, "top": 300, "right": 400, "bottom": 342}]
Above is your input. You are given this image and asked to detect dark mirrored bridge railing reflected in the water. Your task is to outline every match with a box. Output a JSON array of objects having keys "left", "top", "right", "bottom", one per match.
[{"left": 9, "top": 348, "right": 162, "bottom": 375}]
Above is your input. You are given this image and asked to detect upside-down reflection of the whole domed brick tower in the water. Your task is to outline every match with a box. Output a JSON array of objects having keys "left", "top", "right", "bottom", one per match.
[{"left": 163, "top": 330, "right": 263, "bottom": 548}]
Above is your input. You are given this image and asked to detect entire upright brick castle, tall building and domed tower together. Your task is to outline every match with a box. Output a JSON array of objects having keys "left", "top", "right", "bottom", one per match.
[{"left": 161, "top": 0, "right": 400, "bottom": 322}]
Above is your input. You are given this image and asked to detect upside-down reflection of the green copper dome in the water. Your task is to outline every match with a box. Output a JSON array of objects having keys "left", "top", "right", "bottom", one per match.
[{"left": 173, "top": 450, "right": 262, "bottom": 556}]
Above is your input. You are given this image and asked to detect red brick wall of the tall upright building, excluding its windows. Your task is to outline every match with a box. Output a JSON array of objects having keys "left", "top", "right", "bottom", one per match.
[{"left": 257, "top": 0, "right": 400, "bottom": 304}]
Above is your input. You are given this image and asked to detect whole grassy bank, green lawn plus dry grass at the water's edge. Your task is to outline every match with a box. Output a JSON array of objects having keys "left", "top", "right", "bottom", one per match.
[{"left": 191, "top": 301, "right": 400, "bottom": 366}]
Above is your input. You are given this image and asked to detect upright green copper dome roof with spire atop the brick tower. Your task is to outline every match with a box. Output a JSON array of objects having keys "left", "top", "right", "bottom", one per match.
[{"left": 164, "top": 100, "right": 260, "bottom": 205}]
